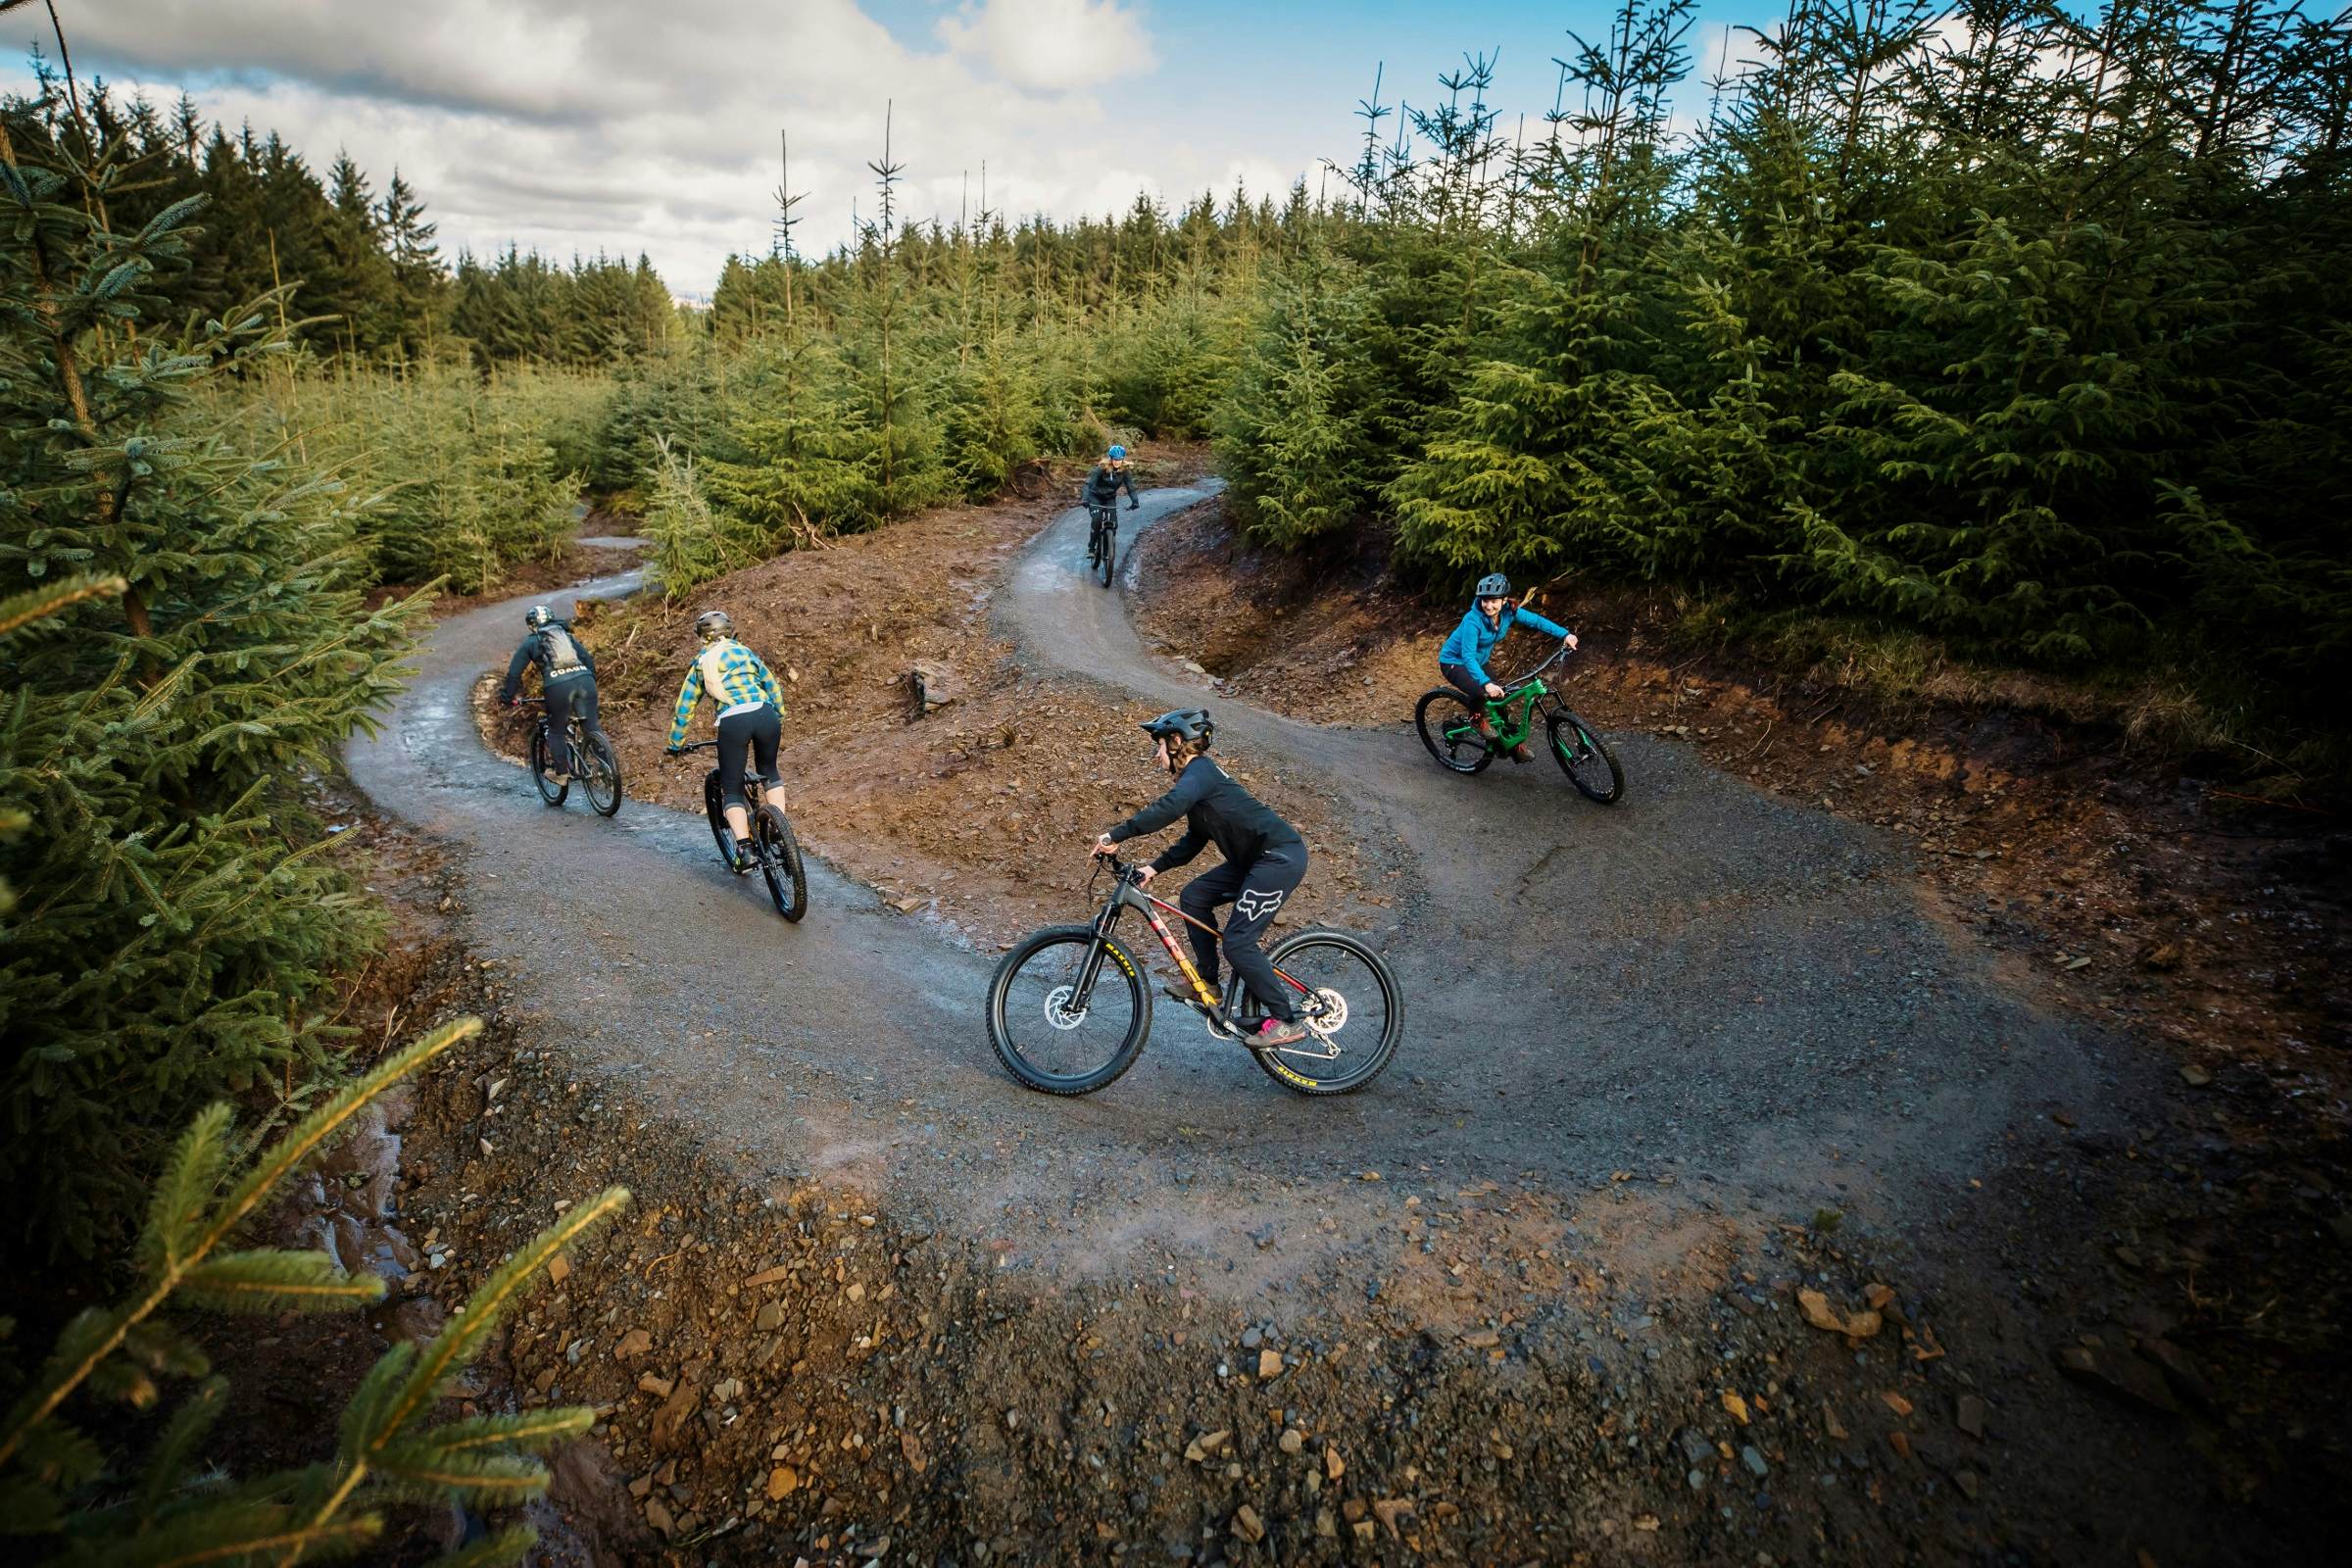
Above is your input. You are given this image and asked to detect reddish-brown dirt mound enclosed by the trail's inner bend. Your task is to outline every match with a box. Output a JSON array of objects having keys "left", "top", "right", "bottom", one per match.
[{"left": 477, "top": 479, "right": 1395, "bottom": 945}]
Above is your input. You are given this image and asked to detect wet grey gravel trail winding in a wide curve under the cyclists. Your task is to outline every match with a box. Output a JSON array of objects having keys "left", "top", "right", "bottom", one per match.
[{"left": 348, "top": 489, "right": 2105, "bottom": 1272}]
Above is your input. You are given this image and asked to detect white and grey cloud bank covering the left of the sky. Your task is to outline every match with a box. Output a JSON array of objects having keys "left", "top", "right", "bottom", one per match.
[{"left": 27, "top": 0, "right": 1242, "bottom": 291}]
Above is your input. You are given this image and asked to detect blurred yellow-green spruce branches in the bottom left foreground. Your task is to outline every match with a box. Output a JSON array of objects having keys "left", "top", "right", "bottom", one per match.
[{"left": 0, "top": 1018, "right": 628, "bottom": 1563}]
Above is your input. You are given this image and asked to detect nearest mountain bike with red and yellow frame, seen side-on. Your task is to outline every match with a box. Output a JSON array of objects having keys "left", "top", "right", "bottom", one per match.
[{"left": 988, "top": 856, "right": 1404, "bottom": 1096}]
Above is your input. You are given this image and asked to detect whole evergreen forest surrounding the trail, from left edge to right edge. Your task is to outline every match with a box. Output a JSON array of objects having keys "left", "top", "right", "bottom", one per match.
[{"left": 0, "top": 0, "right": 2352, "bottom": 1561}]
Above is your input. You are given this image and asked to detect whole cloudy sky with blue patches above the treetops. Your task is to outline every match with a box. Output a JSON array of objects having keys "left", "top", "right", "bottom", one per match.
[{"left": 31, "top": 0, "right": 1781, "bottom": 296}]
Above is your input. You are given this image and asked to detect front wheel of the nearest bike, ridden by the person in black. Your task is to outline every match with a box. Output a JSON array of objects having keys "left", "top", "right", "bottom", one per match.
[{"left": 988, "top": 926, "right": 1152, "bottom": 1096}]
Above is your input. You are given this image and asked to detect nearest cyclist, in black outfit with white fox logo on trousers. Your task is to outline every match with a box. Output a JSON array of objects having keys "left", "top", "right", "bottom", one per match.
[{"left": 1094, "top": 708, "right": 1307, "bottom": 1046}]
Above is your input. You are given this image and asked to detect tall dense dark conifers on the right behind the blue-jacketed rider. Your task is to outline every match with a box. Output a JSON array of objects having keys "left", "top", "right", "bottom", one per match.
[{"left": 1289, "top": 0, "right": 2352, "bottom": 733}]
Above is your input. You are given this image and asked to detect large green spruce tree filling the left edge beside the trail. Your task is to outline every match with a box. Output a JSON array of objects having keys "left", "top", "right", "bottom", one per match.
[{"left": 0, "top": 116, "right": 414, "bottom": 1250}]
